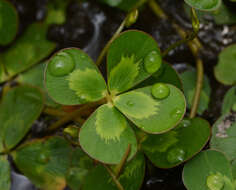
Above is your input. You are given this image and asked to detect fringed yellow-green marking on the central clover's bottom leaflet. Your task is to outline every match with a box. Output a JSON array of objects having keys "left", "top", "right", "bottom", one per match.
[{"left": 95, "top": 104, "right": 127, "bottom": 142}]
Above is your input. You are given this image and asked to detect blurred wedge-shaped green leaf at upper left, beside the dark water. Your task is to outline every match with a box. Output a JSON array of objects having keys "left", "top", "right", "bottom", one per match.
[{"left": 0, "top": 23, "right": 55, "bottom": 82}]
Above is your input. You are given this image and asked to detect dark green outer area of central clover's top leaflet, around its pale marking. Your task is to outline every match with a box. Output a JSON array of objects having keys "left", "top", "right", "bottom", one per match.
[{"left": 107, "top": 30, "right": 161, "bottom": 90}]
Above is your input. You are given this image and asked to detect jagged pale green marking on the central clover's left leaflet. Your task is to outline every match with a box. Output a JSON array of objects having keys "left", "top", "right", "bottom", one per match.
[{"left": 68, "top": 68, "right": 106, "bottom": 101}]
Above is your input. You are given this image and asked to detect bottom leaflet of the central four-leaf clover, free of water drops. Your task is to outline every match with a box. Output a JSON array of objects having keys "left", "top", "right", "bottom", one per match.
[{"left": 79, "top": 104, "right": 137, "bottom": 164}]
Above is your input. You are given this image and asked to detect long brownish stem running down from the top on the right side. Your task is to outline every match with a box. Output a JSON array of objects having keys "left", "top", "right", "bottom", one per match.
[{"left": 149, "top": 0, "right": 204, "bottom": 118}]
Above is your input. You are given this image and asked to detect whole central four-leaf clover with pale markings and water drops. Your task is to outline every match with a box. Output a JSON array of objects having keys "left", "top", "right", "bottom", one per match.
[{"left": 45, "top": 30, "right": 185, "bottom": 164}]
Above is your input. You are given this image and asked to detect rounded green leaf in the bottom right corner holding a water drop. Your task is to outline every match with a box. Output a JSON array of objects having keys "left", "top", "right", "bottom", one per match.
[{"left": 183, "top": 150, "right": 235, "bottom": 190}]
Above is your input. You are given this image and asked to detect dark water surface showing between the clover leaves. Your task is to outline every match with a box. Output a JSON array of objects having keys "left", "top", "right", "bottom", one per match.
[{"left": 0, "top": 0, "right": 236, "bottom": 190}]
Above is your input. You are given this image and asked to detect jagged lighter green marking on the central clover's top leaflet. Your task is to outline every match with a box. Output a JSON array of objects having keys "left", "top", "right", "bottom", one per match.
[{"left": 108, "top": 55, "right": 140, "bottom": 94}]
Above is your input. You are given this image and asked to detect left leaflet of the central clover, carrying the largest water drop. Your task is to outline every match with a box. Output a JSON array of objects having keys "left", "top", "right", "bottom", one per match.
[{"left": 45, "top": 48, "right": 106, "bottom": 105}]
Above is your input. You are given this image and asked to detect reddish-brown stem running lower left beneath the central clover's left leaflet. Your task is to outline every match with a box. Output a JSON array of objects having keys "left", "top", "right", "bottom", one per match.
[{"left": 48, "top": 99, "right": 106, "bottom": 131}]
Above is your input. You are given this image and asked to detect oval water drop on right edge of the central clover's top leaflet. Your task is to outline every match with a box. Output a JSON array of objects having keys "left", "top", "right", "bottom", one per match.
[{"left": 144, "top": 51, "right": 161, "bottom": 74}]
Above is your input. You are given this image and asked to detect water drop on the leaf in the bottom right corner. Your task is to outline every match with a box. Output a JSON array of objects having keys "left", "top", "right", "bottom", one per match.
[{"left": 206, "top": 172, "right": 225, "bottom": 190}]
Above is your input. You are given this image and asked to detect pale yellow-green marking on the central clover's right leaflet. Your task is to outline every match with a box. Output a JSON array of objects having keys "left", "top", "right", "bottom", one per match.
[{"left": 114, "top": 91, "right": 159, "bottom": 119}]
